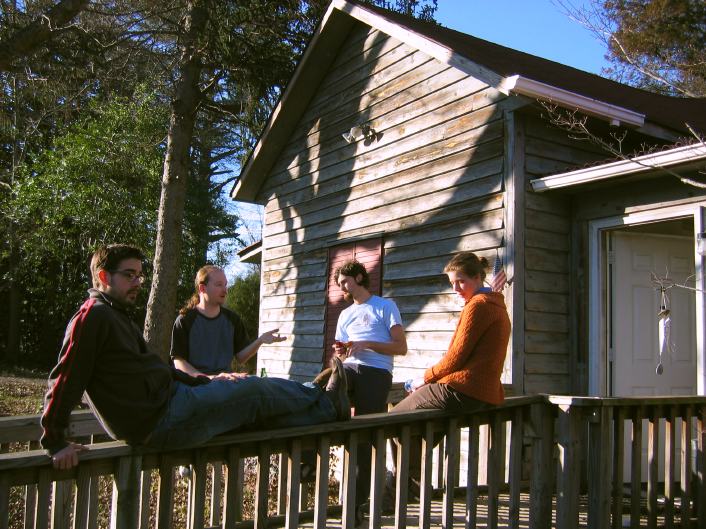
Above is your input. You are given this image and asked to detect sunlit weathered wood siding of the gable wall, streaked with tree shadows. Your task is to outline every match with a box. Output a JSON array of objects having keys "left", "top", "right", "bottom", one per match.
[{"left": 258, "top": 25, "right": 512, "bottom": 380}]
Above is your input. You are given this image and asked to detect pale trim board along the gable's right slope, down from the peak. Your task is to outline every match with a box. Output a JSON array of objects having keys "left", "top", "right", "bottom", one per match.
[{"left": 331, "top": 0, "right": 504, "bottom": 88}]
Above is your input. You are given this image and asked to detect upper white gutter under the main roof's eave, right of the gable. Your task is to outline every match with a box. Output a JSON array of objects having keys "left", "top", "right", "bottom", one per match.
[{"left": 499, "top": 75, "right": 645, "bottom": 127}]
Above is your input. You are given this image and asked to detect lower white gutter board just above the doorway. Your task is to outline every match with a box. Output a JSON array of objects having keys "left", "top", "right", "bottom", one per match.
[{"left": 530, "top": 144, "right": 706, "bottom": 193}]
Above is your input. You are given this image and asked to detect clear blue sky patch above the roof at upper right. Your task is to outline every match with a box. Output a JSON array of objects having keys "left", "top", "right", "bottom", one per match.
[{"left": 436, "top": 0, "right": 607, "bottom": 74}]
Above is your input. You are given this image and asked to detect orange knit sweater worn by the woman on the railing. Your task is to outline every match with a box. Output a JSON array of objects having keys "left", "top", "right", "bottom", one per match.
[{"left": 424, "top": 292, "right": 510, "bottom": 404}]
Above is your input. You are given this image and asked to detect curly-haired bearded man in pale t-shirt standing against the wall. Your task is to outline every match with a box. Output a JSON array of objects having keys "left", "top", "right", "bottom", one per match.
[{"left": 334, "top": 261, "right": 407, "bottom": 514}]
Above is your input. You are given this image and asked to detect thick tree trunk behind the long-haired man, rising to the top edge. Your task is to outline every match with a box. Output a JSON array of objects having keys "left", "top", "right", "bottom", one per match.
[{"left": 144, "top": 1, "right": 207, "bottom": 360}]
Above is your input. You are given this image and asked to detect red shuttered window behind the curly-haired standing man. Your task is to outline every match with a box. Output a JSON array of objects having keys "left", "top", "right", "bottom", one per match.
[{"left": 323, "top": 237, "right": 382, "bottom": 367}]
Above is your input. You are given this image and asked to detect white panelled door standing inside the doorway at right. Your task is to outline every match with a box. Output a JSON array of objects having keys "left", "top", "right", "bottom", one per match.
[{"left": 610, "top": 232, "right": 696, "bottom": 482}]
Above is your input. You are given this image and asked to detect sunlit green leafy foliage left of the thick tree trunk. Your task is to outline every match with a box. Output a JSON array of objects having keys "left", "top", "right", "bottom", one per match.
[{"left": 0, "top": 94, "right": 166, "bottom": 365}]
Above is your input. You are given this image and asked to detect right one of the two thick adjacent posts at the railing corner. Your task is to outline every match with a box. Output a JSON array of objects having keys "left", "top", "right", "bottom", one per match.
[{"left": 556, "top": 404, "right": 583, "bottom": 529}]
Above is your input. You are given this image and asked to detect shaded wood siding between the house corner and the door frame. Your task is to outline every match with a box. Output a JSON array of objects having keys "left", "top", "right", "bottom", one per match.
[{"left": 524, "top": 115, "right": 605, "bottom": 394}]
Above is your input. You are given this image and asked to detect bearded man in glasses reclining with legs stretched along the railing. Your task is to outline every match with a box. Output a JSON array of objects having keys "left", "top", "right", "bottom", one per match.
[{"left": 41, "top": 244, "right": 350, "bottom": 469}]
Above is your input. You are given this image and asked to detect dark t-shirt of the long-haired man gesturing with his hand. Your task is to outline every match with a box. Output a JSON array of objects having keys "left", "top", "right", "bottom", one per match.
[{"left": 170, "top": 308, "right": 250, "bottom": 375}]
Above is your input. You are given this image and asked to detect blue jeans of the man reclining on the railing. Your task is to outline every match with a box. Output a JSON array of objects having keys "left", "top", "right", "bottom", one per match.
[{"left": 145, "top": 376, "right": 336, "bottom": 450}]
